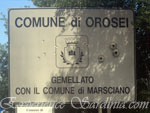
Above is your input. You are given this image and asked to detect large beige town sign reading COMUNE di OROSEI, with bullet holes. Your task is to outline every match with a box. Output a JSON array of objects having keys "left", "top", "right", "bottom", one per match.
[{"left": 9, "top": 8, "right": 135, "bottom": 102}]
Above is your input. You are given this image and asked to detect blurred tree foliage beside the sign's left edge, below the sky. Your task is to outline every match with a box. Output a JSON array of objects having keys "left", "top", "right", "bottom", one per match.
[{"left": 0, "top": 13, "right": 8, "bottom": 100}]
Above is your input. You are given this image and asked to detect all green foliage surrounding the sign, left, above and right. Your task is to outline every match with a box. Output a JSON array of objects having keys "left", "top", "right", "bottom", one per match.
[{"left": 0, "top": 0, "right": 150, "bottom": 113}]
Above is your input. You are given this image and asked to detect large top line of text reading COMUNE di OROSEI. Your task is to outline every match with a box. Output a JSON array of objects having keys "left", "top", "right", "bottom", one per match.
[{"left": 14, "top": 16, "right": 129, "bottom": 28}]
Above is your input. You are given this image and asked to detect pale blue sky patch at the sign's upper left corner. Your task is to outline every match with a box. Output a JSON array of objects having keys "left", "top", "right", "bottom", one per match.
[{"left": 0, "top": 0, "right": 35, "bottom": 44}]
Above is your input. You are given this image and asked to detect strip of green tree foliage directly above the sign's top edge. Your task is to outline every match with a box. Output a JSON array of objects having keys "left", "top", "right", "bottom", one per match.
[{"left": 32, "top": 0, "right": 132, "bottom": 8}]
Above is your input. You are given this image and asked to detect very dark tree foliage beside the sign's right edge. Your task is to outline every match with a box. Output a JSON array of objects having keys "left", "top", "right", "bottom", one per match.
[{"left": 134, "top": 0, "right": 150, "bottom": 100}]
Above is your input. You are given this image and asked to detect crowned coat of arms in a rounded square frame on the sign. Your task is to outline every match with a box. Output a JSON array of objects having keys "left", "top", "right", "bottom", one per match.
[{"left": 56, "top": 36, "right": 88, "bottom": 67}]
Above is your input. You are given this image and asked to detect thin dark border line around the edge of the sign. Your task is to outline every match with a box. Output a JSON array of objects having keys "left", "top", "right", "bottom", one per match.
[{"left": 8, "top": 7, "right": 137, "bottom": 104}]
